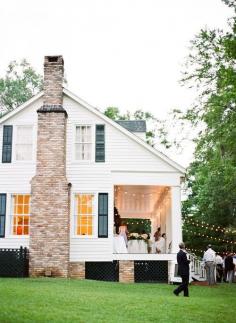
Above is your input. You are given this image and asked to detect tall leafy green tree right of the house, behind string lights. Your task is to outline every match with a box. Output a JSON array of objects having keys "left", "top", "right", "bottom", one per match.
[{"left": 181, "top": 0, "right": 236, "bottom": 256}]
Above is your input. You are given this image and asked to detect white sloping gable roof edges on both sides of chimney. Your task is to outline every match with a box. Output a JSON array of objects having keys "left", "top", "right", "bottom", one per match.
[{"left": 0, "top": 88, "right": 185, "bottom": 175}]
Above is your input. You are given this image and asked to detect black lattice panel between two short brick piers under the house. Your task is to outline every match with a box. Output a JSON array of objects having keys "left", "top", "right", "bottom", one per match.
[{"left": 85, "top": 261, "right": 119, "bottom": 281}]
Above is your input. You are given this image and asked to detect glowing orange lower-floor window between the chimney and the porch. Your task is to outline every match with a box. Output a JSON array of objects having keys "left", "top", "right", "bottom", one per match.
[{"left": 75, "top": 194, "right": 94, "bottom": 236}]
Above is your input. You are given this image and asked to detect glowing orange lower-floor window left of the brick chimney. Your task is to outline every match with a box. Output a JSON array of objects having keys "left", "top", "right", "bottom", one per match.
[{"left": 12, "top": 194, "right": 30, "bottom": 235}]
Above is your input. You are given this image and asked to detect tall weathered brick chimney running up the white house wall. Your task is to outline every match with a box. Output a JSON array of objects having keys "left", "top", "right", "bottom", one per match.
[{"left": 29, "top": 56, "right": 69, "bottom": 277}]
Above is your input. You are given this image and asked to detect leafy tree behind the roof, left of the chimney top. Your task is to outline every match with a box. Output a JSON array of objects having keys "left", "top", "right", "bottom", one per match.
[{"left": 0, "top": 59, "right": 42, "bottom": 112}]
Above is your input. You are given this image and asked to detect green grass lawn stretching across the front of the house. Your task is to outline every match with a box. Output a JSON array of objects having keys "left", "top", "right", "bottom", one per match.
[{"left": 0, "top": 278, "right": 236, "bottom": 323}]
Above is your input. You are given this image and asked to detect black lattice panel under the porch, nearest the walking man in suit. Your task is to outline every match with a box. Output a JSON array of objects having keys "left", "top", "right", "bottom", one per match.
[{"left": 134, "top": 260, "right": 168, "bottom": 283}]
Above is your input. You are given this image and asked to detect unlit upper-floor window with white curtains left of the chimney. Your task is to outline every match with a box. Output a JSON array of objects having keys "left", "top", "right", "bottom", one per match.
[{"left": 15, "top": 126, "right": 33, "bottom": 160}]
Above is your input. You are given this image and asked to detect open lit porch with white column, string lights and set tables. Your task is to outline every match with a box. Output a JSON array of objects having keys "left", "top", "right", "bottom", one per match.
[{"left": 113, "top": 185, "right": 182, "bottom": 259}]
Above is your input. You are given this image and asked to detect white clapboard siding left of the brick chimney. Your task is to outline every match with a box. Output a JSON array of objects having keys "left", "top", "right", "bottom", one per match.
[{"left": 0, "top": 98, "right": 43, "bottom": 248}]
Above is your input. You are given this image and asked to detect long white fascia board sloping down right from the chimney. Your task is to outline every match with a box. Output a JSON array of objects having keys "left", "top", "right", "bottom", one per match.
[{"left": 63, "top": 88, "right": 186, "bottom": 175}]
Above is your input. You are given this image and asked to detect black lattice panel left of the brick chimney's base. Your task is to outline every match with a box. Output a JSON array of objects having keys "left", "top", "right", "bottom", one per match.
[{"left": 0, "top": 248, "right": 29, "bottom": 277}]
